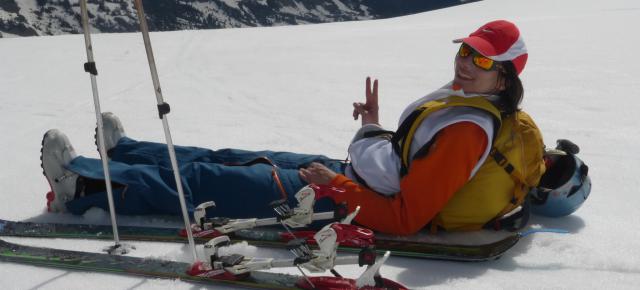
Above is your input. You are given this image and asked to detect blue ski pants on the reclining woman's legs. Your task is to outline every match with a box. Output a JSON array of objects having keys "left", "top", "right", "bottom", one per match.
[{"left": 66, "top": 137, "right": 346, "bottom": 218}]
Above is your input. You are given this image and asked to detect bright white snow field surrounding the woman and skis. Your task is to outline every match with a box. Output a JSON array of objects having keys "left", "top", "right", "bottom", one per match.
[{"left": 0, "top": 0, "right": 640, "bottom": 289}]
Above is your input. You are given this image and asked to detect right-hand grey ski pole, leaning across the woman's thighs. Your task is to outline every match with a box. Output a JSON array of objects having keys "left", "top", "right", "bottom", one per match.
[{"left": 134, "top": 0, "right": 198, "bottom": 263}]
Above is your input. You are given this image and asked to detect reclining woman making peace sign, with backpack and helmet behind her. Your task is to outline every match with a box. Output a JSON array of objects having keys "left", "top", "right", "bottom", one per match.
[{"left": 41, "top": 20, "right": 590, "bottom": 234}]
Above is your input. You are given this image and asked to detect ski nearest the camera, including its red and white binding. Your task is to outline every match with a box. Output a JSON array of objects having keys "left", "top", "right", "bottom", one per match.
[{"left": 0, "top": 209, "right": 407, "bottom": 290}]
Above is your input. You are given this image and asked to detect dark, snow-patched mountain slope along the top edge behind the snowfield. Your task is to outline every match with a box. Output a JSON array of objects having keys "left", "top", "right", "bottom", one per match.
[{"left": 0, "top": 0, "right": 469, "bottom": 36}]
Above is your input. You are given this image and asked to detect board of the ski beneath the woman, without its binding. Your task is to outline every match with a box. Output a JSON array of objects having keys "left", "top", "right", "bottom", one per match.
[{"left": 0, "top": 220, "right": 522, "bottom": 262}]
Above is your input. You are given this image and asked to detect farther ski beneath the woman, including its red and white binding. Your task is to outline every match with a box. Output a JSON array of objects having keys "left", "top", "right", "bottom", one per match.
[{"left": 0, "top": 185, "right": 522, "bottom": 262}]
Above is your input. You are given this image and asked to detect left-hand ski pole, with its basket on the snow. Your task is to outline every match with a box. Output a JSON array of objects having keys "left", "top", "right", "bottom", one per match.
[{"left": 80, "top": 0, "right": 129, "bottom": 254}]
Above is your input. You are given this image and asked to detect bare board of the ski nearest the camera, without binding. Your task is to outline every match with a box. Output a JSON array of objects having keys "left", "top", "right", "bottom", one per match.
[{"left": 0, "top": 240, "right": 406, "bottom": 289}]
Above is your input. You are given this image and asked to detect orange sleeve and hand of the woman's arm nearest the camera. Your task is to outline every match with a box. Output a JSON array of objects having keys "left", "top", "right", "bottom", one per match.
[{"left": 331, "top": 122, "right": 488, "bottom": 235}]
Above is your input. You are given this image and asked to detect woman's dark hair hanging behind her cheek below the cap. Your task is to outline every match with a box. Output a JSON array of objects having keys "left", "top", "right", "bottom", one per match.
[{"left": 498, "top": 61, "right": 524, "bottom": 115}]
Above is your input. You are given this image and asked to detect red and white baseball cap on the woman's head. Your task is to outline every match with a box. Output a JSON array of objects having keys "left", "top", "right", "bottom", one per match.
[{"left": 453, "top": 20, "right": 528, "bottom": 74}]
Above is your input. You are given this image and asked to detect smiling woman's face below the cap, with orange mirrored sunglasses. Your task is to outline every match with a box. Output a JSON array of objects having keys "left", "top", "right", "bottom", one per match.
[{"left": 453, "top": 48, "right": 504, "bottom": 94}]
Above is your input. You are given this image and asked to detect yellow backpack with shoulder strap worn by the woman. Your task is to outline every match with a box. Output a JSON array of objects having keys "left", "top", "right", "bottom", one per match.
[{"left": 394, "top": 96, "right": 545, "bottom": 230}]
